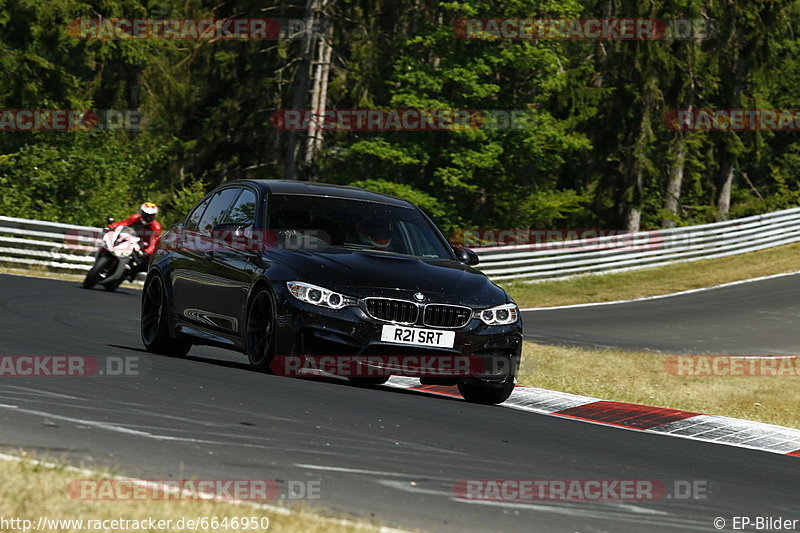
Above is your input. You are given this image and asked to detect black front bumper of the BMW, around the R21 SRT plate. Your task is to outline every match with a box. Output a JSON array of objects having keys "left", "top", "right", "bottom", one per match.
[{"left": 275, "top": 291, "right": 522, "bottom": 385}]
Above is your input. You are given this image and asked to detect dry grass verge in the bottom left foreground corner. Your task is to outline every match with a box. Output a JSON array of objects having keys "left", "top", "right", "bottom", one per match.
[{"left": 0, "top": 454, "right": 394, "bottom": 533}]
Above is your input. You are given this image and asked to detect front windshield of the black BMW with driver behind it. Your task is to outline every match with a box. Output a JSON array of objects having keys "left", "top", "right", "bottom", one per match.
[{"left": 267, "top": 194, "right": 452, "bottom": 259}]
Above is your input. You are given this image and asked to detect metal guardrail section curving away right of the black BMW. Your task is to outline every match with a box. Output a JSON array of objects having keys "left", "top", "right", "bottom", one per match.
[{"left": 475, "top": 208, "right": 800, "bottom": 281}]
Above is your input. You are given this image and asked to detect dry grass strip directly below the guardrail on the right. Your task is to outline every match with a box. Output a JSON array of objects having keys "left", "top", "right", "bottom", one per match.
[{"left": 501, "top": 243, "right": 800, "bottom": 308}]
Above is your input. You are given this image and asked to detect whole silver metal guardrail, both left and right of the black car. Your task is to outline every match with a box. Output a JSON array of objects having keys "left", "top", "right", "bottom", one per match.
[{"left": 0, "top": 208, "right": 800, "bottom": 281}]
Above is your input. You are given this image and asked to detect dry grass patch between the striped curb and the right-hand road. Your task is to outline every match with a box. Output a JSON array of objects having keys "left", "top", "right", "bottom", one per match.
[{"left": 518, "top": 342, "right": 800, "bottom": 429}]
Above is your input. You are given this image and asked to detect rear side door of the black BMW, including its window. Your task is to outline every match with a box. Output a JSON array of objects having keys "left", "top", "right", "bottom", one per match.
[{"left": 175, "top": 187, "right": 241, "bottom": 333}]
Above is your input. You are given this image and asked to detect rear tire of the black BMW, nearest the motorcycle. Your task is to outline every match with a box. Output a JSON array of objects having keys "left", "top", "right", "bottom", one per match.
[{"left": 140, "top": 274, "right": 192, "bottom": 357}]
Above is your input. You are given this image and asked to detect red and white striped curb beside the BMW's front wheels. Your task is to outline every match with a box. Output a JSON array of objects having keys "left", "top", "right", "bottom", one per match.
[{"left": 387, "top": 377, "right": 800, "bottom": 457}]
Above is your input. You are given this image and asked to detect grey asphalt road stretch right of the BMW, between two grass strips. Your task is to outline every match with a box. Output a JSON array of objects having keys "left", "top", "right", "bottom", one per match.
[{"left": 522, "top": 274, "right": 800, "bottom": 355}]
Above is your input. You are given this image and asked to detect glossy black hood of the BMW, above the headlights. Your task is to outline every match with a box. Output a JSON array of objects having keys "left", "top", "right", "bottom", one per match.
[{"left": 269, "top": 249, "right": 508, "bottom": 306}]
